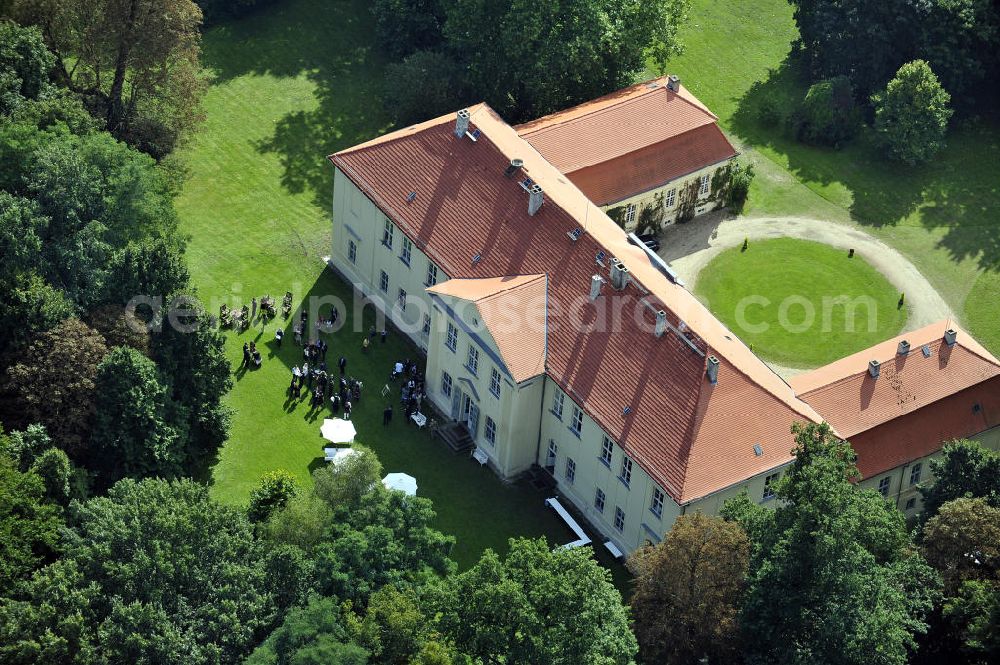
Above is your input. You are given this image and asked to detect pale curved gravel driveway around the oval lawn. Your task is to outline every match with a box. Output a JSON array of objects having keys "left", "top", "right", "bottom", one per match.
[{"left": 660, "top": 213, "right": 955, "bottom": 377}]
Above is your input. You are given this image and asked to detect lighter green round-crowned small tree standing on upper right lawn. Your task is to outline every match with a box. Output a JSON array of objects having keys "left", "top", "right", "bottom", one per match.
[{"left": 872, "top": 60, "right": 952, "bottom": 165}]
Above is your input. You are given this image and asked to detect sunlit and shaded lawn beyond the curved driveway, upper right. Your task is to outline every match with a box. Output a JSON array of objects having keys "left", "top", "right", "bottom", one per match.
[{"left": 669, "top": 0, "right": 1000, "bottom": 353}]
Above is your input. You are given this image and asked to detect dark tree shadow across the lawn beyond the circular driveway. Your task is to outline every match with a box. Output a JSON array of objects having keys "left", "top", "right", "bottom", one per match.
[{"left": 732, "top": 53, "right": 1000, "bottom": 268}]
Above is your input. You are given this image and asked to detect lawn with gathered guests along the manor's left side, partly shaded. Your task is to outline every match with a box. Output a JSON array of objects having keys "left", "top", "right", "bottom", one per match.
[{"left": 177, "top": 0, "right": 625, "bottom": 572}]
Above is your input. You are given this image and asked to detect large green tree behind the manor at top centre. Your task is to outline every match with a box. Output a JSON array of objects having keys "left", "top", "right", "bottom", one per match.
[{"left": 444, "top": 0, "right": 689, "bottom": 122}]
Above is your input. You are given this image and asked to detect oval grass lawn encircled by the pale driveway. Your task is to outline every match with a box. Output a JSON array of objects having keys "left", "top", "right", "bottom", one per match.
[{"left": 695, "top": 238, "right": 906, "bottom": 367}]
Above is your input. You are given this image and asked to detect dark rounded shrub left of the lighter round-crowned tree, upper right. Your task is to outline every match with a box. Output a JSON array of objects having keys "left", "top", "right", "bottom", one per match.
[{"left": 796, "top": 76, "right": 861, "bottom": 147}]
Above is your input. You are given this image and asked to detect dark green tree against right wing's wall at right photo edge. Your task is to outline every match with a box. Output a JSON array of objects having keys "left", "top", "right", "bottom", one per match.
[{"left": 920, "top": 439, "right": 1000, "bottom": 520}]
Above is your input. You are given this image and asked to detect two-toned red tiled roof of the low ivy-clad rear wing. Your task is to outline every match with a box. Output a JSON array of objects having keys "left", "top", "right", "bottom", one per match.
[{"left": 516, "top": 77, "right": 736, "bottom": 206}]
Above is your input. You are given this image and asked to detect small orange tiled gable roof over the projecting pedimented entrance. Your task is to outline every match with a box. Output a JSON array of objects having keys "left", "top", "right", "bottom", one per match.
[{"left": 427, "top": 275, "right": 546, "bottom": 383}]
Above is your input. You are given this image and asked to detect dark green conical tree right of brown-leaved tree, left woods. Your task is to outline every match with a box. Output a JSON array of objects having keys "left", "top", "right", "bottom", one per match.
[{"left": 91, "top": 346, "right": 187, "bottom": 483}]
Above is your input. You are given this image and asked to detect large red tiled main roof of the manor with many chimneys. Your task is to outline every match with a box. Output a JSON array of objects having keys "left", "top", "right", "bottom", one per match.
[{"left": 330, "top": 104, "right": 819, "bottom": 503}]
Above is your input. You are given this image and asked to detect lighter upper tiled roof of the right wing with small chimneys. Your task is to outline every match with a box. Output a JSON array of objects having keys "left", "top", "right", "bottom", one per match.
[{"left": 791, "top": 321, "right": 1000, "bottom": 438}]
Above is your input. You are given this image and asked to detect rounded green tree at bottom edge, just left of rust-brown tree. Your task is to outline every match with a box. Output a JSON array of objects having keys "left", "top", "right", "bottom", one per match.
[{"left": 438, "top": 539, "right": 637, "bottom": 665}]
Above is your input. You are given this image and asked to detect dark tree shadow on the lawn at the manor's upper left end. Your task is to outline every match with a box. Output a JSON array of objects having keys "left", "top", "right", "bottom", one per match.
[{"left": 203, "top": 0, "right": 391, "bottom": 209}]
